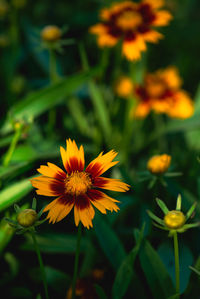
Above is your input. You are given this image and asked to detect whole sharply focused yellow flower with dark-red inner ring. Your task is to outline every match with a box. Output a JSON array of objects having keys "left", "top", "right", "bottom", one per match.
[{"left": 31, "top": 139, "right": 129, "bottom": 229}]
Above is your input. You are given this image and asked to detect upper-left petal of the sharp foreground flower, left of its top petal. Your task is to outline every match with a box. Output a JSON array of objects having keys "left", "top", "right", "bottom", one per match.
[{"left": 37, "top": 162, "right": 67, "bottom": 180}]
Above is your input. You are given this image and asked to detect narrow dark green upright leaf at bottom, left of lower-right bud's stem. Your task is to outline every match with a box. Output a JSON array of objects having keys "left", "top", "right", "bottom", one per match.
[{"left": 112, "top": 228, "right": 144, "bottom": 299}]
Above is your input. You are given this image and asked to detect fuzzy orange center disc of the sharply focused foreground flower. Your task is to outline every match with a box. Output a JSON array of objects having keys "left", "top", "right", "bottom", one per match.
[{"left": 65, "top": 171, "right": 92, "bottom": 196}]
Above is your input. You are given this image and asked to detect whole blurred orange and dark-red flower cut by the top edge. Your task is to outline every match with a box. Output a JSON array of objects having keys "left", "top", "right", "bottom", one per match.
[{"left": 90, "top": 0, "right": 172, "bottom": 60}]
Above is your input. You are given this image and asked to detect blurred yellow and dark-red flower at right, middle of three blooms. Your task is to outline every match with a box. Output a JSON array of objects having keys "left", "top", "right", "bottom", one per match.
[{"left": 131, "top": 67, "right": 194, "bottom": 119}]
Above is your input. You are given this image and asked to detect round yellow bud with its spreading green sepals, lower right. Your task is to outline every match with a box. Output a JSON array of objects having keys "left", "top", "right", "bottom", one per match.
[{"left": 148, "top": 195, "right": 200, "bottom": 236}]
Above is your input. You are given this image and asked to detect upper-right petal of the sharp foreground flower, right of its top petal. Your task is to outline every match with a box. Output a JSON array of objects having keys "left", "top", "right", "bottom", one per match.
[{"left": 85, "top": 150, "right": 119, "bottom": 178}]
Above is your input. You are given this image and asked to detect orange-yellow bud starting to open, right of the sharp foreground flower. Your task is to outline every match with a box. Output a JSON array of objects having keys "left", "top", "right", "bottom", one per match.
[{"left": 147, "top": 154, "right": 171, "bottom": 174}]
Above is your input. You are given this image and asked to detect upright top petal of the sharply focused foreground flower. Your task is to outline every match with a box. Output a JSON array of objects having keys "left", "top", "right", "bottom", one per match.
[{"left": 60, "top": 139, "right": 85, "bottom": 174}]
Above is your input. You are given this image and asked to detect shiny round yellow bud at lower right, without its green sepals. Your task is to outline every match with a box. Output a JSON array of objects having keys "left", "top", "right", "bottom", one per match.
[{"left": 164, "top": 210, "right": 186, "bottom": 229}]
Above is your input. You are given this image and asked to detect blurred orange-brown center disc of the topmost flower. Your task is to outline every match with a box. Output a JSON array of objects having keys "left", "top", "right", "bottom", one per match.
[{"left": 116, "top": 11, "right": 142, "bottom": 30}]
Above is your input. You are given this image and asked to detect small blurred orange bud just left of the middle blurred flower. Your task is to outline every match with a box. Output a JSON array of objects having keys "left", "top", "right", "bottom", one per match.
[{"left": 115, "top": 76, "right": 133, "bottom": 98}]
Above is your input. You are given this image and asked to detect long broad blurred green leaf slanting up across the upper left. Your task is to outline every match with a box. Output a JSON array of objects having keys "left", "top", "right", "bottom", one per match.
[{"left": 2, "top": 71, "right": 97, "bottom": 133}]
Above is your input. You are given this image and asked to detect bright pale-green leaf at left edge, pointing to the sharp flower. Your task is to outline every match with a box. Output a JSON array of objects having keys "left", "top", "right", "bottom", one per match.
[{"left": 0, "top": 178, "right": 32, "bottom": 212}]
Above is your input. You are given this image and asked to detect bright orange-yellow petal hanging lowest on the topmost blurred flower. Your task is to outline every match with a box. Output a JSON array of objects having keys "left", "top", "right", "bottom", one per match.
[{"left": 122, "top": 35, "right": 146, "bottom": 61}]
